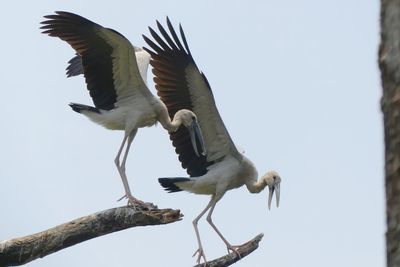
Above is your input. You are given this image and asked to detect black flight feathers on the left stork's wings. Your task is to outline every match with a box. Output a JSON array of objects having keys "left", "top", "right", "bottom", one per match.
[{"left": 41, "top": 11, "right": 117, "bottom": 110}]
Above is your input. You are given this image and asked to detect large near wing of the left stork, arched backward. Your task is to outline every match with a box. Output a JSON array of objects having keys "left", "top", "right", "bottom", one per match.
[{"left": 41, "top": 11, "right": 151, "bottom": 110}]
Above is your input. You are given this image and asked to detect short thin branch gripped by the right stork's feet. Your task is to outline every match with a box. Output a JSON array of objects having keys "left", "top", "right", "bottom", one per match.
[{"left": 194, "top": 234, "right": 264, "bottom": 267}]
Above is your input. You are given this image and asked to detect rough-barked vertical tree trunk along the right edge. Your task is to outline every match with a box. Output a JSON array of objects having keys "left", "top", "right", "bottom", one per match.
[{"left": 379, "top": 0, "right": 400, "bottom": 267}]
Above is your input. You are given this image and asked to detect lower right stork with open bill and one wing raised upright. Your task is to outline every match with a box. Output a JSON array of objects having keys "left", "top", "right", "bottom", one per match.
[{"left": 143, "top": 18, "right": 281, "bottom": 263}]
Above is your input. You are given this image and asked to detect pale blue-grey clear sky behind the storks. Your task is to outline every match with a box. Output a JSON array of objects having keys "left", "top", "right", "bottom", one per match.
[{"left": 0, "top": 0, "right": 386, "bottom": 267}]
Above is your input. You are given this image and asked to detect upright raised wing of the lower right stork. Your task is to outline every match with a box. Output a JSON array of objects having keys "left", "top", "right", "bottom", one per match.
[{"left": 143, "top": 18, "right": 241, "bottom": 176}]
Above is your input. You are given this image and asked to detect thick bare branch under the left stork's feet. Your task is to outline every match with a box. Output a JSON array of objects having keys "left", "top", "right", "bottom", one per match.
[{"left": 0, "top": 206, "right": 183, "bottom": 266}]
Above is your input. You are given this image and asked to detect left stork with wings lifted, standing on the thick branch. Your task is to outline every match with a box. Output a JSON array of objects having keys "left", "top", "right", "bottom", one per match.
[{"left": 41, "top": 11, "right": 205, "bottom": 209}]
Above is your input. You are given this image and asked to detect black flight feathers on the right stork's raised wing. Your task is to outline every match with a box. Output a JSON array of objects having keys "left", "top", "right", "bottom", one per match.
[{"left": 143, "top": 17, "right": 213, "bottom": 177}]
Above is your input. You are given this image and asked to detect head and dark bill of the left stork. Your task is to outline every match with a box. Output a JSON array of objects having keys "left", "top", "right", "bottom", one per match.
[{"left": 173, "top": 109, "right": 206, "bottom": 156}]
